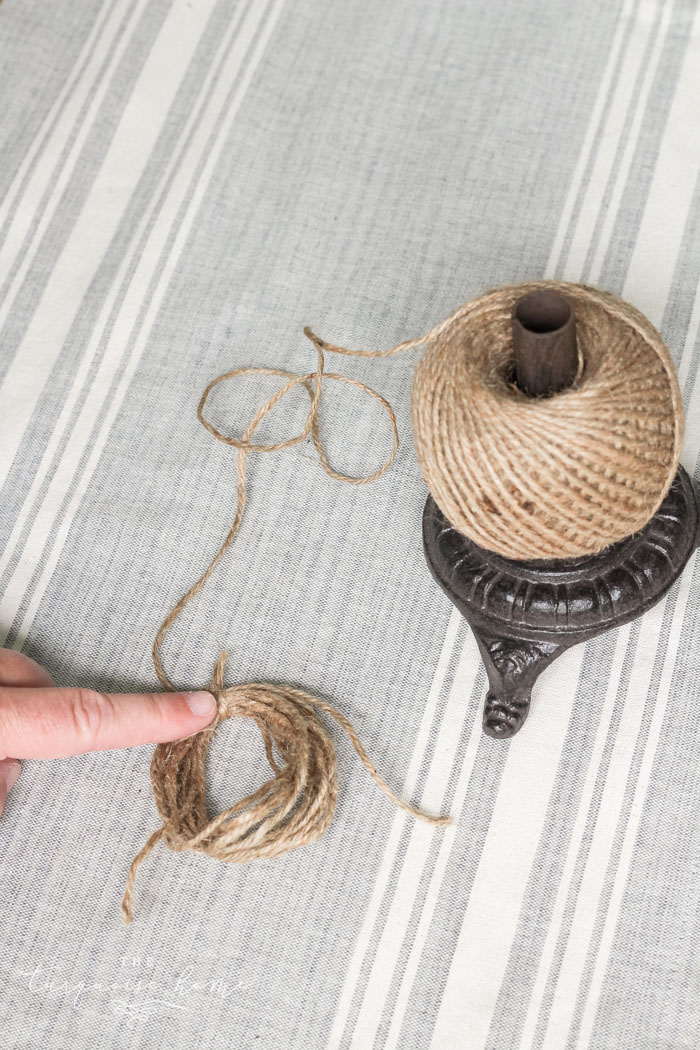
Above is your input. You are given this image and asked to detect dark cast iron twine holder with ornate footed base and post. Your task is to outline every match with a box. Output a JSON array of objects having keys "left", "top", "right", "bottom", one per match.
[{"left": 423, "top": 289, "right": 700, "bottom": 739}]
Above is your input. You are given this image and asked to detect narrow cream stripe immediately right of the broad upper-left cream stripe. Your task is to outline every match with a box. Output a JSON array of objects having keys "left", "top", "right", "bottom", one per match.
[{"left": 0, "top": 4, "right": 248, "bottom": 609}]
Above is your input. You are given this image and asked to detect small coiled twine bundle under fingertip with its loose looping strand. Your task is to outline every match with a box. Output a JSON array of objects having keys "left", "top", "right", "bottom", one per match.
[{"left": 122, "top": 349, "right": 451, "bottom": 924}]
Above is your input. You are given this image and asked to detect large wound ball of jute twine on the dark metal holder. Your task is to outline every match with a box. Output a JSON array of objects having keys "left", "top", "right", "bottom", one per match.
[{"left": 306, "top": 280, "right": 683, "bottom": 560}]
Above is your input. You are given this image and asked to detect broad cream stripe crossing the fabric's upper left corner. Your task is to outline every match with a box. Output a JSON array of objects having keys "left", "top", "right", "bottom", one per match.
[{"left": 0, "top": 0, "right": 220, "bottom": 487}]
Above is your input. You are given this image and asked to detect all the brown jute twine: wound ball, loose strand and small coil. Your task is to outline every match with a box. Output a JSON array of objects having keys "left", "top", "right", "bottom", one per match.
[{"left": 122, "top": 281, "right": 683, "bottom": 922}]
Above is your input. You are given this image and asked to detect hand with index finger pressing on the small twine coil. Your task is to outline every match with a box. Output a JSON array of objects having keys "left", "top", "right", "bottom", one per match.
[{"left": 0, "top": 649, "right": 216, "bottom": 813}]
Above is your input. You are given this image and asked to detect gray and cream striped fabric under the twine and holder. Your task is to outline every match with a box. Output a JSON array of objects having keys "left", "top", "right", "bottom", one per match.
[{"left": 0, "top": 0, "right": 700, "bottom": 1050}]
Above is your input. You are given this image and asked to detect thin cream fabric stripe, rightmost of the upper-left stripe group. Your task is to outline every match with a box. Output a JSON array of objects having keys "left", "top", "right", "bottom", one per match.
[{"left": 8, "top": 0, "right": 284, "bottom": 649}]
